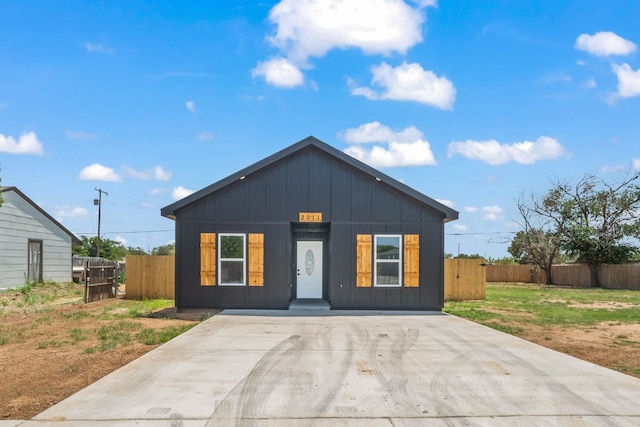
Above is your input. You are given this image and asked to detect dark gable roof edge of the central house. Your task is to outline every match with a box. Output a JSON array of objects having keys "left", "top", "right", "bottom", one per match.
[{"left": 160, "top": 136, "right": 458, "bottom": 222}]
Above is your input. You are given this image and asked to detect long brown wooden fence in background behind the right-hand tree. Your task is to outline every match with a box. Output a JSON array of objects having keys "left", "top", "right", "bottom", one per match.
[{"left": 487, "top": 264, "right": 640, "bottom": 290}]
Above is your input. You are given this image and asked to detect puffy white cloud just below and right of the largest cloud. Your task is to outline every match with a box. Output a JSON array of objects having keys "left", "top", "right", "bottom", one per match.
[{"left": 351, "top": 62, "right": 456, "bottom": 110}]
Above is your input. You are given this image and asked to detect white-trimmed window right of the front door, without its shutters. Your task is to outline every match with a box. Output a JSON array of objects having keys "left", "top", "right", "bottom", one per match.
[{"left": 373, "top": 235, "right": 402, "bottom": 286}]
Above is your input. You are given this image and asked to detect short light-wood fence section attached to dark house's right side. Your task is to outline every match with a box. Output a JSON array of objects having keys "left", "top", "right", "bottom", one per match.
[{"left": 444, "top": 259, "right": 486, "bottom": 301}]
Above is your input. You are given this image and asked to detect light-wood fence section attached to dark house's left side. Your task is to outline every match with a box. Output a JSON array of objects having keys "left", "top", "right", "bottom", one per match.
[{"left": 125, "top": 255, "right": 176, "bottom": 299}]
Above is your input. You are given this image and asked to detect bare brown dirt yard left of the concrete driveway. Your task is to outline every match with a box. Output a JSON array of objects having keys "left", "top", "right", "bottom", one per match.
[{"left": 0, "top": 292, "right": 205, "bottom": 420}]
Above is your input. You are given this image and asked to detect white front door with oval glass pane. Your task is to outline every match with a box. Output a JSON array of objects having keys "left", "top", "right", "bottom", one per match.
[{"left": 296, "top": 241, "right": 322, "bottom": 299}]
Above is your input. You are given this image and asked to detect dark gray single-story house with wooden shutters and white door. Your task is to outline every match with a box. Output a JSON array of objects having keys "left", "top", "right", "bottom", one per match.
[{"left": 161, "top": 136, "right": 458, "bottom": 310}]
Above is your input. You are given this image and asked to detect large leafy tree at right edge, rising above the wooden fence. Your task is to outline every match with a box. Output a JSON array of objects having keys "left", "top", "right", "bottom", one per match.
[{"left": 519, "top": 172, "right": 640, "bottom": 286}]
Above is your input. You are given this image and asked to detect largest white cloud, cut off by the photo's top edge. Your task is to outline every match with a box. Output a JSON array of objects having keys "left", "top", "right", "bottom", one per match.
[{"left": 267, "top": 0, "right": 435, "bottom": 64}]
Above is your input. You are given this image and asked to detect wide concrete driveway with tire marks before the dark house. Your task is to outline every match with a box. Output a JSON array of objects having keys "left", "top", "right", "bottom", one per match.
[{"left": 8, "top": 311, "right": 640, "bottom": 427}]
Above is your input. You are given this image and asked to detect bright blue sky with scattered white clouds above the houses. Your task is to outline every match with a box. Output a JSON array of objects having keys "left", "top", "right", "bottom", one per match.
[{"left": 0, "top": 0, "right": 640, "bottom": 258}]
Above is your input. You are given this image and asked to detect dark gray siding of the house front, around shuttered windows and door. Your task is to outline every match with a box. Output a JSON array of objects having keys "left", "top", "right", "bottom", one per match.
[{"left": 162, "top": 137, "right": 458, "bottom": 310}]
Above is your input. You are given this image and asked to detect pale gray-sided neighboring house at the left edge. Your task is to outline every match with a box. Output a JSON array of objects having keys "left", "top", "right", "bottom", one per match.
[{"left": 0, "top": 187, "right": 81, "bottom": 287}]
